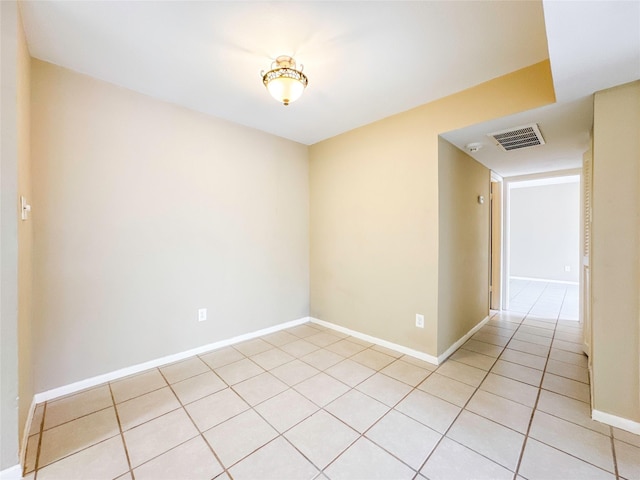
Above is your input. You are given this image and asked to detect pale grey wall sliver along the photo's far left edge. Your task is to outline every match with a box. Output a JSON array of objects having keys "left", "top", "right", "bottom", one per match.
[{"left": 0, "top": 1, "right": 20, "bottom": 470}]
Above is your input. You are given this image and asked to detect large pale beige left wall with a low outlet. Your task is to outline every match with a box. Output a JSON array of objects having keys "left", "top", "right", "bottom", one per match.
[{"left": 31, "top": 60, "right": 309, "bottom": 391}]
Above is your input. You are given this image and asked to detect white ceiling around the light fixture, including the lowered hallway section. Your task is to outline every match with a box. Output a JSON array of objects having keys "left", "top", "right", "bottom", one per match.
[{"left": 21, "top": 0, "right": 640, "bottom": 175}]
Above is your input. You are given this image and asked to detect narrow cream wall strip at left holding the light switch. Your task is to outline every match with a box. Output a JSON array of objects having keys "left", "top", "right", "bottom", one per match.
[{"left": 18, "top": 3, "right": 34, "bottom": 454}]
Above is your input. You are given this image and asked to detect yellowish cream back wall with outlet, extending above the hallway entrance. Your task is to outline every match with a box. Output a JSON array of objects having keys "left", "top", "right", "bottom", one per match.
[{"left": 310, "top": 61, "right": 555, "bottom": 355}]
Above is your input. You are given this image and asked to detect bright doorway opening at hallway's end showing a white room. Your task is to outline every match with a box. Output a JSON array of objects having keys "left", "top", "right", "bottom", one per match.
[{"left": 502, "top": 170, "right": 581, "bottom": 322}]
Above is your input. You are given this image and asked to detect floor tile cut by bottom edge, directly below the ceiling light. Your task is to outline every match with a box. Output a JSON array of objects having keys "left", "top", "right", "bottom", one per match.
[{"left": 229, "top": 437, "right": 319, "bottom": 480}]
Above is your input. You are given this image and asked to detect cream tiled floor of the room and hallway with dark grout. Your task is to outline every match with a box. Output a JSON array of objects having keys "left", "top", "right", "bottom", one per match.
[{"left": 26, "top": 313, "right": 640, "bottom": 480}]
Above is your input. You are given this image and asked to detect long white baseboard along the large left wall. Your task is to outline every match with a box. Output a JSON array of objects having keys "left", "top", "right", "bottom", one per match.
[{"left": 33, "top": 317, "right": 310, "bottom": 404}]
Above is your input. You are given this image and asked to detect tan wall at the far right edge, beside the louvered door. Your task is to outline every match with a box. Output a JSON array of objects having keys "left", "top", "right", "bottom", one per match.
[{"left": 591, "top": 81, "right": 640, "bottom": 422}]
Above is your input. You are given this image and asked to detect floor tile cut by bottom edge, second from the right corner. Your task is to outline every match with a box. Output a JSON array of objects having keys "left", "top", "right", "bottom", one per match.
[{"left": 519, "top": 438, "right": 615, "bottom": 480}]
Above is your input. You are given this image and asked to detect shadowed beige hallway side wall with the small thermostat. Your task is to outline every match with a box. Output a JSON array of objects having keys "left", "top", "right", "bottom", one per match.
[{"left": 438, "top": 138, "right": 491, "bottom": 355}]
